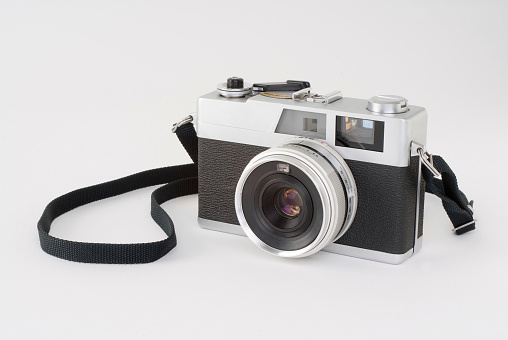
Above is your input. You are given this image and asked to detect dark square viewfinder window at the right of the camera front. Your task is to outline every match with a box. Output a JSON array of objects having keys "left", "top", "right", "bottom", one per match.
[{"left": 335, "top": 116, "right": 385, "bottom": 152}]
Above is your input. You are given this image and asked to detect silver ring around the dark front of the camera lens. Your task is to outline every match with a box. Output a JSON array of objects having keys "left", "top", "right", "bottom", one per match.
[{"left": 235, "top": 138, "right": 357, "bottom": 257}]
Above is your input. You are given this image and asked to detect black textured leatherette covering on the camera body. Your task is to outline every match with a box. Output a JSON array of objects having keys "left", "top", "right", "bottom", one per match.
[{"left": 198, "top": 138, "right": 425, "bottom": 254}]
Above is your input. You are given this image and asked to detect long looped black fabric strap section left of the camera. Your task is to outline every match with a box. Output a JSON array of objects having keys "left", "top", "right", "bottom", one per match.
[{"left": 37, "top": 124, "right": 198, "bottom": 264}]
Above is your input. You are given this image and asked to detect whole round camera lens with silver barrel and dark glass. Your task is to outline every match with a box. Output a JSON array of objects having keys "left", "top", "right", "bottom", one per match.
[{"left": 235, "top": 139, "right": 357, "bottom": 257}]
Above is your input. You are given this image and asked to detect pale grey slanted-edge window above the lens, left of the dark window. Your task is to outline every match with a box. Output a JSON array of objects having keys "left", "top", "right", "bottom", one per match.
[{"left": 275, "top": 109, "right": 326, "bottom": 139}]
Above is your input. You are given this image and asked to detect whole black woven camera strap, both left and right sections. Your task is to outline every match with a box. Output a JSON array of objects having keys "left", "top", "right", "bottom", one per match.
[{"left": 37, "top": 121, "right": 475, "bottom": 264}]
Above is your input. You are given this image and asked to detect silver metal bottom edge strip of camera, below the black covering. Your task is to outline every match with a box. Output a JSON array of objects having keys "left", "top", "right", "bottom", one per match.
[{"left": 198, "top": 218, "right": 416, "bottom": 264}]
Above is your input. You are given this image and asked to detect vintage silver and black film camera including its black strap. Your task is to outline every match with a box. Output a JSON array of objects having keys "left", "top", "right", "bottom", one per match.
[{"left": 37, "top": 77, "right": 476, "bottom": 264}]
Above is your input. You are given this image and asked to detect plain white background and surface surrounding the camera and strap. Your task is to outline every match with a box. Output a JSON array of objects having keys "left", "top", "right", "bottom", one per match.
[{"left": 0, "top": 0, "right": 508, "bottom": 339}]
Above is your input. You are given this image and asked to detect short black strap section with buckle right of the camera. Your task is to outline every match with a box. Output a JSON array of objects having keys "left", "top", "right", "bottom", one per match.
[{"left": 422, "top": 156, "right": 476, "bottom": 235}]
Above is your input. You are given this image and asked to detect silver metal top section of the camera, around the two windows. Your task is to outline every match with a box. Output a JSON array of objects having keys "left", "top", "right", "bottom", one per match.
[{"left": 195, "top": 91, "right": 427, "bottom": 167}]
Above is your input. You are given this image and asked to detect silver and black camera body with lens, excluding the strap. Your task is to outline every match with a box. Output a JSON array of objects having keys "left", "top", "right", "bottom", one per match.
[{"left": 194, "top": 77, "right": 427, "bottom": 264}]
